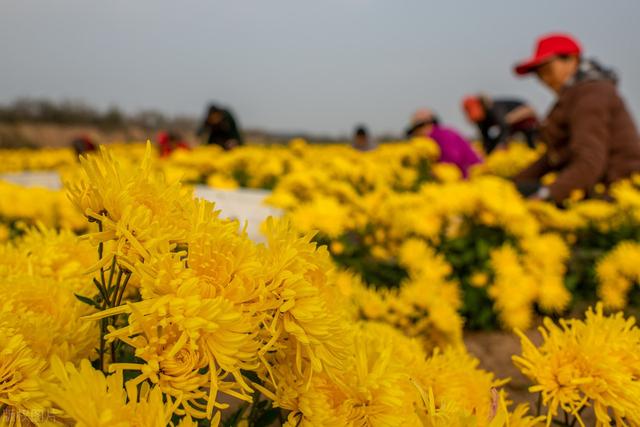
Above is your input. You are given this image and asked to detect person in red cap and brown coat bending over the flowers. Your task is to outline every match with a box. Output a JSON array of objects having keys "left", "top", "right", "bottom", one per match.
[{"left": 515, "top": 34, "right": 640, "bottom": 203}]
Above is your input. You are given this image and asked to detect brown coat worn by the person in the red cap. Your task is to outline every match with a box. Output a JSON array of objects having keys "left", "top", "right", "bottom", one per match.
[{"left": 515, "top": 59, "right": 640, "bottom": 202}]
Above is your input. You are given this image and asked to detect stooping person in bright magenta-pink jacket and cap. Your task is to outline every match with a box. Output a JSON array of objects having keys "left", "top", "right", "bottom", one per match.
[{"left": 407, "top": 108, "right": 482, "bottom": 178}]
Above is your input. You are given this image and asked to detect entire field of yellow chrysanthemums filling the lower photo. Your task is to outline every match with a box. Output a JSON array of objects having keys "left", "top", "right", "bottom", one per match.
[{"left": 0, "top": 139, "right": 640, "bottom": 427}]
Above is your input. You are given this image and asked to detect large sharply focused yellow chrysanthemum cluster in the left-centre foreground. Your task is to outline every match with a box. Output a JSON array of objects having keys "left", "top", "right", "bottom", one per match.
[{"left": 65, "top": 144, "right": 348, "bottom": 423}]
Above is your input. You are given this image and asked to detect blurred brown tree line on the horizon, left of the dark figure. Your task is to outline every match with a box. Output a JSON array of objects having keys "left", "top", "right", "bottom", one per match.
[{"left": 0, "top": 98, "right": 196, "bottom": 131}]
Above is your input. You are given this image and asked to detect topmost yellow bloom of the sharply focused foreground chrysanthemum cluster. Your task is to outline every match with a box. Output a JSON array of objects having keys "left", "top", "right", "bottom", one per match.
[{"left": 68, "top": 146, "right": 194, "bottom": 278}]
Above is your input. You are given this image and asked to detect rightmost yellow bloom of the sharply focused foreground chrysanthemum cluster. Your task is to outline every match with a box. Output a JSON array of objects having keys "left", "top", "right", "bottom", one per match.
[{"left": 259, "top": 219, "right": 349, "bottom": 378}]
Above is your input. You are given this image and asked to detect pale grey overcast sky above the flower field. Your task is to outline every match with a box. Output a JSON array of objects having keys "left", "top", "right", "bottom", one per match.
[{"left": 0, "top": 0, "right": 640, "bottom": 135}]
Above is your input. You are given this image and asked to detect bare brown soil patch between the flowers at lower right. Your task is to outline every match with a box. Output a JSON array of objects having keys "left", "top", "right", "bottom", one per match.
[{"left": 464, "top": 330, "right": 595, "bottom": 426}]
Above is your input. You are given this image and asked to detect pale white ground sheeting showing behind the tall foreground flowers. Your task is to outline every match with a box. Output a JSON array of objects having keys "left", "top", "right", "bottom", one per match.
[{"left": 0, "top": 172, "right": 281, "bottom": 241}]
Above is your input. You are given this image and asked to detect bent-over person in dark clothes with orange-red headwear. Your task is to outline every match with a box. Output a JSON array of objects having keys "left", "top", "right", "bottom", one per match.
[{"left": 462, "top": 94, "right": 538, "bottom": 154}]
